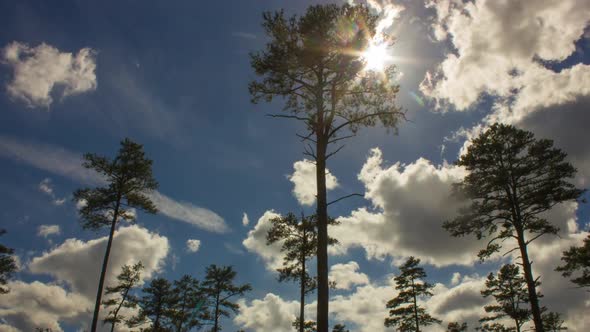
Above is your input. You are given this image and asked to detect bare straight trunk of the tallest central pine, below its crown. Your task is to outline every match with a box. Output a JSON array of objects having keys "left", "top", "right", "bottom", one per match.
[{"left": 316, "top": 136, "right": 330, "bottom": 332}]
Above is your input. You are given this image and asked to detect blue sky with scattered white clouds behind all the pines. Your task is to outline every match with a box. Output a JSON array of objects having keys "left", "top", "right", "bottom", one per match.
[{"left": 0, "top": 0, "right": 590, "bottom": 332}]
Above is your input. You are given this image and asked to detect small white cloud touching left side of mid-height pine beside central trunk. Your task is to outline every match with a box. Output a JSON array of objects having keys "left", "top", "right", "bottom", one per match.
[{"left": 242, "top": 210, "right": 284, "bottom": 271}]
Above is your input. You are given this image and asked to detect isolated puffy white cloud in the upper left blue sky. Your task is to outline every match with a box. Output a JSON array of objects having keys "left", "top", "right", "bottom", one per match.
[{"left": 1, "top": 42, "right": 97, "bottom": 107}]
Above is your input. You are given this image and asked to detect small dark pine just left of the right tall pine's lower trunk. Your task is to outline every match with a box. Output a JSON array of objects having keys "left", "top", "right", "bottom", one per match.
[{"left": 480, "top": 264, "right": 531, "bottom": 332}]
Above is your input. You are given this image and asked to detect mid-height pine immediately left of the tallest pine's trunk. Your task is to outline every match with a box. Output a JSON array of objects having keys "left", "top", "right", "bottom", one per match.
[{"left": 266, "top": 213, "right": 336, "bottom": 332}]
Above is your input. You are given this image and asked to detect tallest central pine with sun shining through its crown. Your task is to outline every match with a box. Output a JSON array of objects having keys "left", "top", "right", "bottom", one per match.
[{"left": 249, "top": 4, "right": 403, "bottom": 332}]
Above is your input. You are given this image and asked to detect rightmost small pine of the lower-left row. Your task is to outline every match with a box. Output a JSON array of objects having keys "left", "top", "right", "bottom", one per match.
[{"left": 202, "top": 264, "right": 252, "bottom": 332}]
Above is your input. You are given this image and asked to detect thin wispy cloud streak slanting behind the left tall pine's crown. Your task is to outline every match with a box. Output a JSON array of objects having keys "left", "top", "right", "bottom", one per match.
[{"left": 0, "top": 136, "right": 229, "bottom": 233}]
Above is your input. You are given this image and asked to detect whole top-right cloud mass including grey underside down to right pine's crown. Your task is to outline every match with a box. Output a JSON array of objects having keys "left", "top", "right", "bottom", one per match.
[{"left": 421, "top": 0, "right": 590, "bottom": 186}]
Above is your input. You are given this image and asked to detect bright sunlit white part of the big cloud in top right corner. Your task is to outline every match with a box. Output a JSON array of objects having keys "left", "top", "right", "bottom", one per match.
[{"left": 421, "top": 0, "right": 590, "bottom": 114}]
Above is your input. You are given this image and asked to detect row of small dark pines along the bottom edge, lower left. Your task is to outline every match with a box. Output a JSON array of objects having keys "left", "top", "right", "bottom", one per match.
[{"left": 102, "top": 262, "right": 252, "bottom": 332}]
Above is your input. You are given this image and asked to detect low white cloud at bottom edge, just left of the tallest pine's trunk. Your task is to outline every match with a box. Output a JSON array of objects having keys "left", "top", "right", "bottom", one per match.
[{"left": 234, "top": 293, "right": 302, "bottom": 332}]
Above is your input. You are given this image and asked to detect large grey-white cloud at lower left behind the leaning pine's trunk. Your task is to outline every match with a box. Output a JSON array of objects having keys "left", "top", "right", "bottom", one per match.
[{"left": 0, "top": 225, "right": 169, "bottom": 331}]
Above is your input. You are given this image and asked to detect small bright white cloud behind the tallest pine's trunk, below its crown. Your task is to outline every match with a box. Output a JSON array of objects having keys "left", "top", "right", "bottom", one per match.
[{"left": 289, "top": 159, "right": 338, "bottom": 206}]
